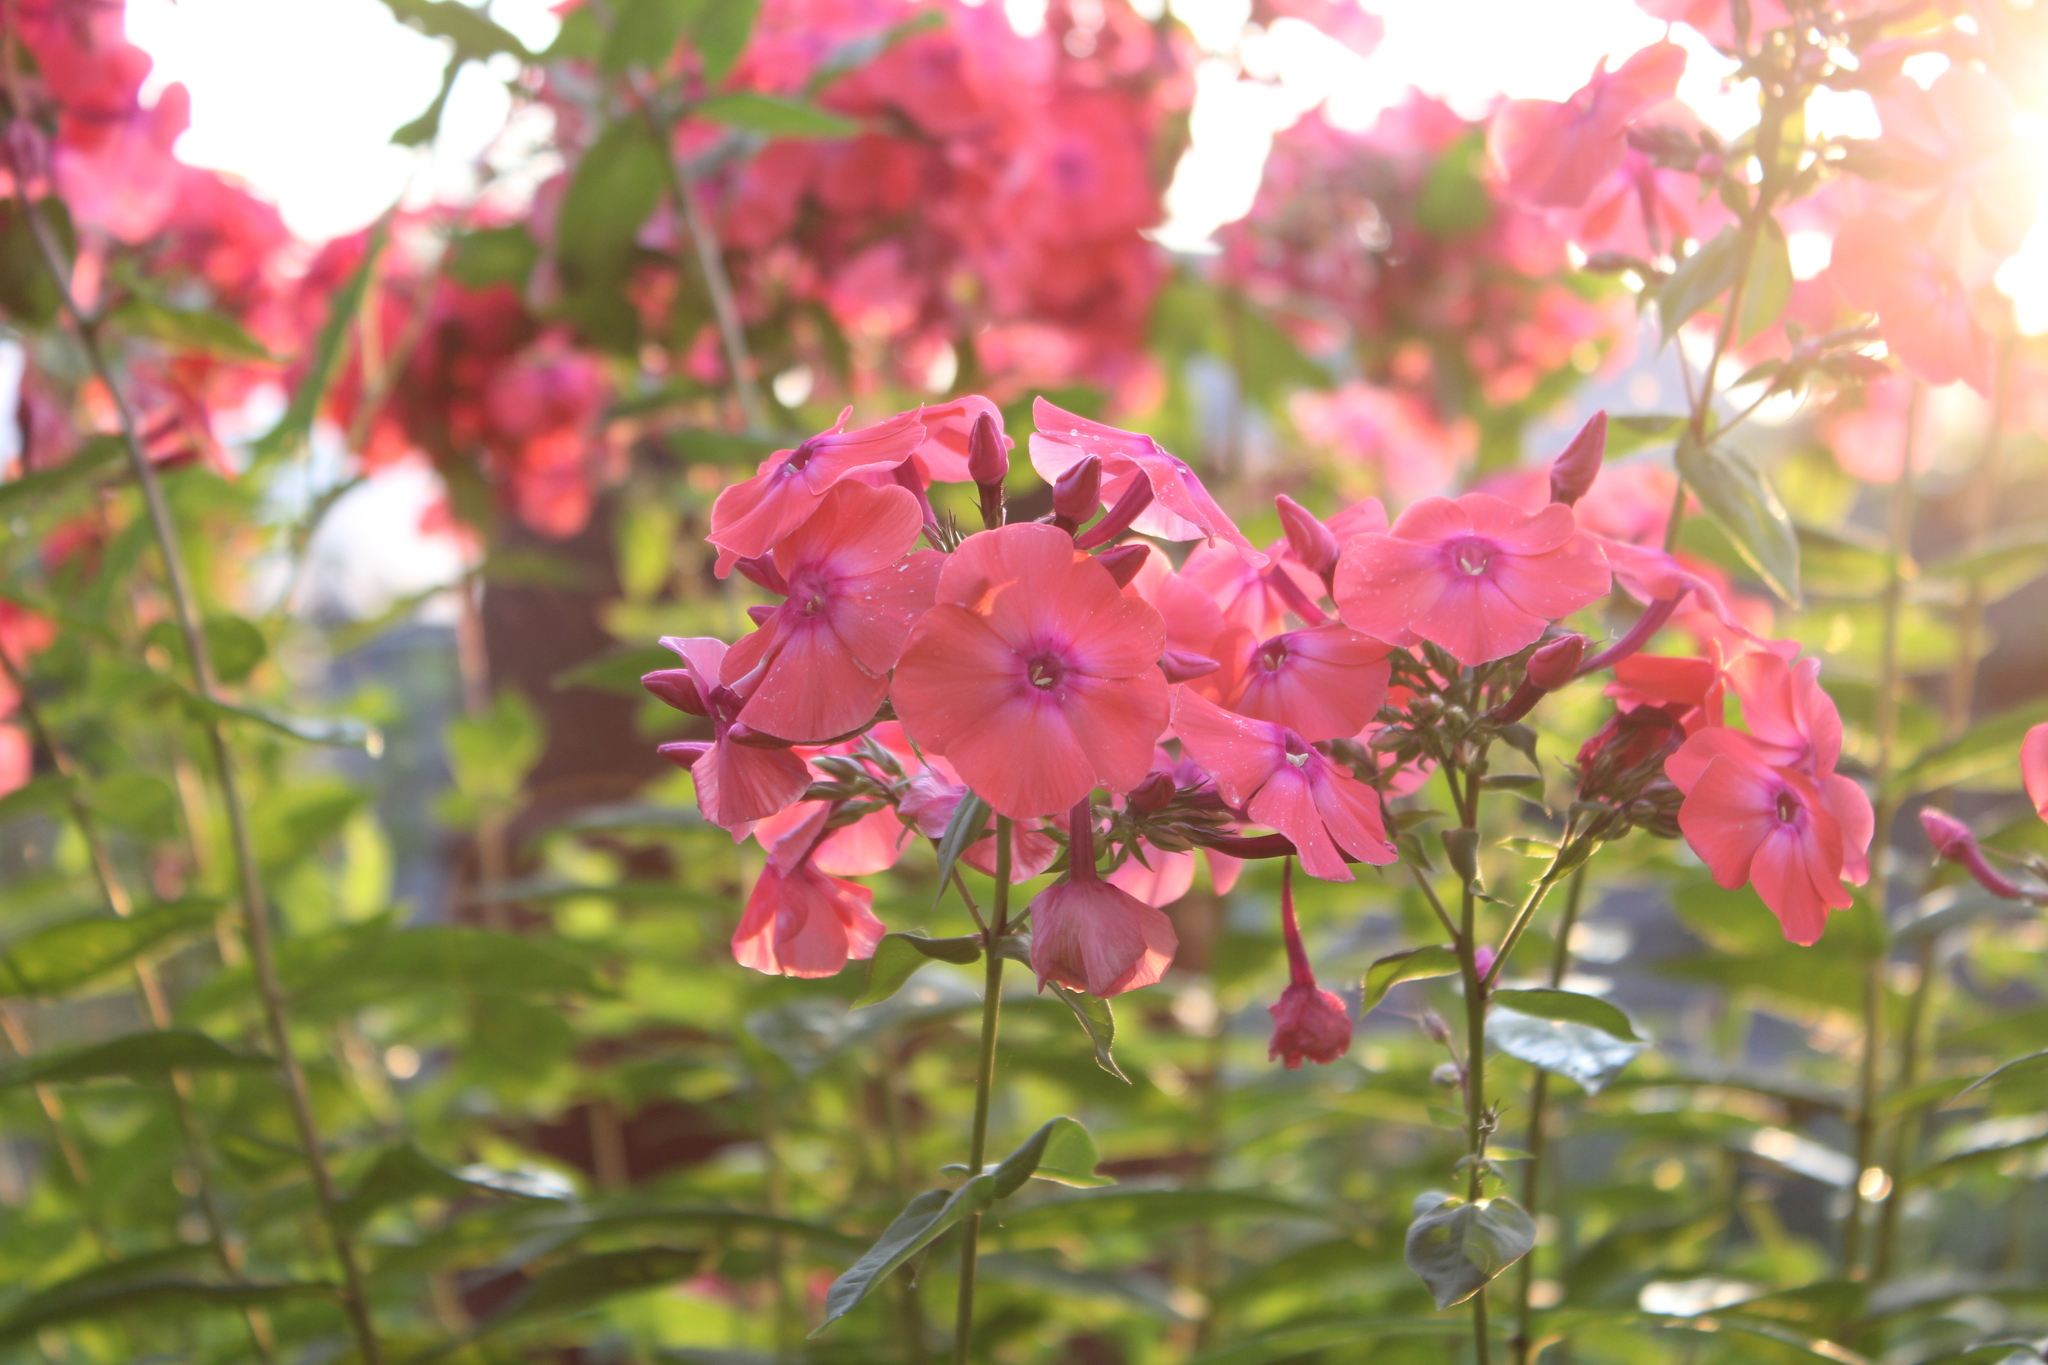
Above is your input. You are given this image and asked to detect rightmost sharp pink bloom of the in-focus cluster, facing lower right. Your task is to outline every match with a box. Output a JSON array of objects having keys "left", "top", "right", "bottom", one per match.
[{"left": 1665, "top": 726, "right": 1874, "bottom": 943}]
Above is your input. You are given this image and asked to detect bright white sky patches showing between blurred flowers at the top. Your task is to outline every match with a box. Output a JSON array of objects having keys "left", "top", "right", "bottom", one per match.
[{"left": 127, "top": 0, "right": 1714, "bottom": 248}]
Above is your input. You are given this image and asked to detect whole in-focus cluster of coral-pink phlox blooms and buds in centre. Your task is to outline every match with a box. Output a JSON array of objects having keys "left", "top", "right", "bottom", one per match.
[{"left": 643, "top": 397, "right": 1872, "bottom": 1064}]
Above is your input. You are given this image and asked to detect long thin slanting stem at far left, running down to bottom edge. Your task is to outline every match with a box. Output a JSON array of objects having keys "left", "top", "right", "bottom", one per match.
[{"left": 14, "top": 170, "right": 383, "bottom": 1365}]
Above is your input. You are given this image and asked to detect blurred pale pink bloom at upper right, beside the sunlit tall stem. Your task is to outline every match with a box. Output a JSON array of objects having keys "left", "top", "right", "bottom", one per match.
[{"left": 1487, "top": 41, "right": 1686, "bottom": 209}]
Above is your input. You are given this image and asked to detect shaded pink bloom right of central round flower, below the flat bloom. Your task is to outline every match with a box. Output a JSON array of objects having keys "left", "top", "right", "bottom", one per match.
[{"left": 1225, "top": 622, "right": 1393, "bottom": 743}]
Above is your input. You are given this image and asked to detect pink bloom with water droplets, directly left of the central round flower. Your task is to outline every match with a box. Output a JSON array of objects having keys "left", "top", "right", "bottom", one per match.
[{"left": 721, "top": 481, "right": 944, "bottom": 743}]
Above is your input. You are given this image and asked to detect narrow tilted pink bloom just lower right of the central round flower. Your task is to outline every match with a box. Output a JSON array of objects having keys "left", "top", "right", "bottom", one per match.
[{"left": 1174, "top": 688, "right": 1395, "bottom": 882}]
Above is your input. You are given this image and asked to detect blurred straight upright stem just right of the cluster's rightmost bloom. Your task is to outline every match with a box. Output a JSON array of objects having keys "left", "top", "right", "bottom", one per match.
[{"left": 1841, "top": 379, "right": 1921, "bottom": 1277}]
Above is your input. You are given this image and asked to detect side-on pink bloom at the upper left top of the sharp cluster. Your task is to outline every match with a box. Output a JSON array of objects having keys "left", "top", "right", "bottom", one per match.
[{"left": 705, "top": 407, "right": 924, "bottom": 577}]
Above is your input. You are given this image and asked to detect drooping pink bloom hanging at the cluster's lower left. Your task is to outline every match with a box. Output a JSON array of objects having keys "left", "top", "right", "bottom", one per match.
[{"left": 733, "top": 802, "right": 889, "bottom": 976}]
